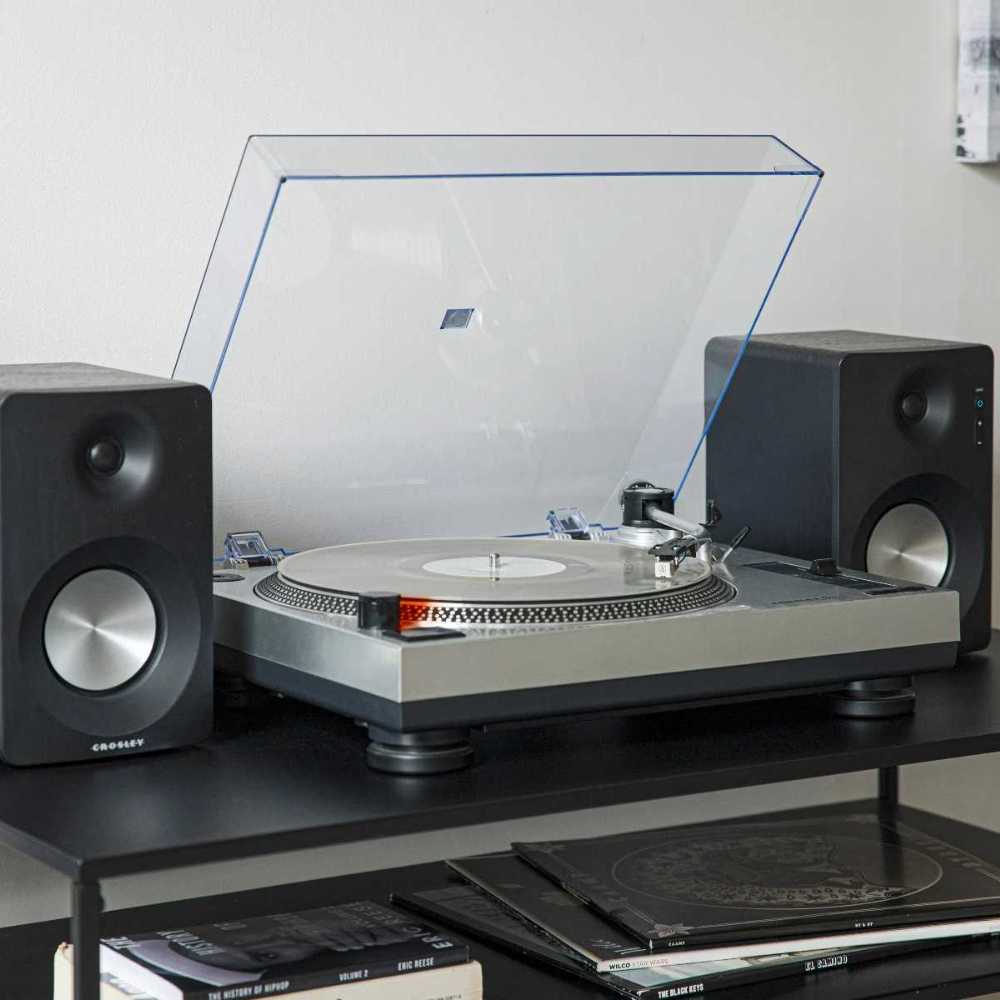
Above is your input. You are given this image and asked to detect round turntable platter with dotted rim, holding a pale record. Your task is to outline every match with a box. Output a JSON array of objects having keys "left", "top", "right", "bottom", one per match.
[{"left": 250, "top": 538, "right": 734, "bottom": 625}]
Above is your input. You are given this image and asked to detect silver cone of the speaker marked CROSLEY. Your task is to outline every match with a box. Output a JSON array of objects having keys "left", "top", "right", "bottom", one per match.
[{"left": 44, "top": 569, "right": 156, "bottom": 691}]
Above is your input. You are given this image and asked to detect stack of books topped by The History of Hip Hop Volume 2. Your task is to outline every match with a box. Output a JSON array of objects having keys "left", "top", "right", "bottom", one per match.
[{"left": 53, "top": 901, "right": 483, "bottom": 1000}]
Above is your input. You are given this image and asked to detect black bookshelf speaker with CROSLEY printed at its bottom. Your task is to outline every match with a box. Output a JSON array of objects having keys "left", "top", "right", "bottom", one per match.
[{"left": 0, "top": 364, "right": 212, "bottom": 764}]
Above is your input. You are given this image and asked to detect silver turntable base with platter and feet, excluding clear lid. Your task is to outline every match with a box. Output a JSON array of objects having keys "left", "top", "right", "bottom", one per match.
[{"left": 215, "top": 539, "right": 958, "bottom": 773}]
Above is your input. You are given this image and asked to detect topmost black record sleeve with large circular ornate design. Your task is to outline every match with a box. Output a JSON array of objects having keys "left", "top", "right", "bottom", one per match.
[{"left": 513, "top": 812, "right": 1000, "bottom": 948}]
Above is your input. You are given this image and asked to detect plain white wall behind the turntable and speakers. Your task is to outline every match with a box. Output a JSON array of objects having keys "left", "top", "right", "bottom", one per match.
[{"left": 0, "top": 0, "right": 1000, "bottom": 923}]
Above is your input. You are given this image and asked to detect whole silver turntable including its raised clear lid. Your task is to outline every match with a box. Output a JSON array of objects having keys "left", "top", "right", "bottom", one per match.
[{"left": 175, "top": 136, "right": 958, "bottom": 773}]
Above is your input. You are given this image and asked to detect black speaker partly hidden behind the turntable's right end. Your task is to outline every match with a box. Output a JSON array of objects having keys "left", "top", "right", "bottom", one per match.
[{"left": 705, "top": 330, "right": 993, "bottom": 650}]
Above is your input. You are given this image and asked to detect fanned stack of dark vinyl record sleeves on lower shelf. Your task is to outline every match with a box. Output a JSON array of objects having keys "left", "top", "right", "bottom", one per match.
[{"left": 393, "top": 811, "right": 1000, "bottom": 998}]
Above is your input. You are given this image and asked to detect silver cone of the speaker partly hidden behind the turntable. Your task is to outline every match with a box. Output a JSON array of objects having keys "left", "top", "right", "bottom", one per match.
[{"left": 865, "top": 503, "right": 951, "bottom": 587}]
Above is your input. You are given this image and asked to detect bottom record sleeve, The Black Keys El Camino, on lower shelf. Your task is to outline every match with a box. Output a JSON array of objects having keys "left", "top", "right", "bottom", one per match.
[{"left": 392, "top": 879, "right": 944, "bottom": 1000}]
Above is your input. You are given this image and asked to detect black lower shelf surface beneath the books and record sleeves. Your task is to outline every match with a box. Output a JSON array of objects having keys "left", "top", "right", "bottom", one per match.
[{"left": 0, "top": 803, "right": 1000, "bottom": 1000}]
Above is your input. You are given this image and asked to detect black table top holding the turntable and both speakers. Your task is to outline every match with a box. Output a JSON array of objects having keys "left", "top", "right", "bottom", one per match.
[{"left": 0, "top": 633, "right": 1000, "bottom": 878}]
